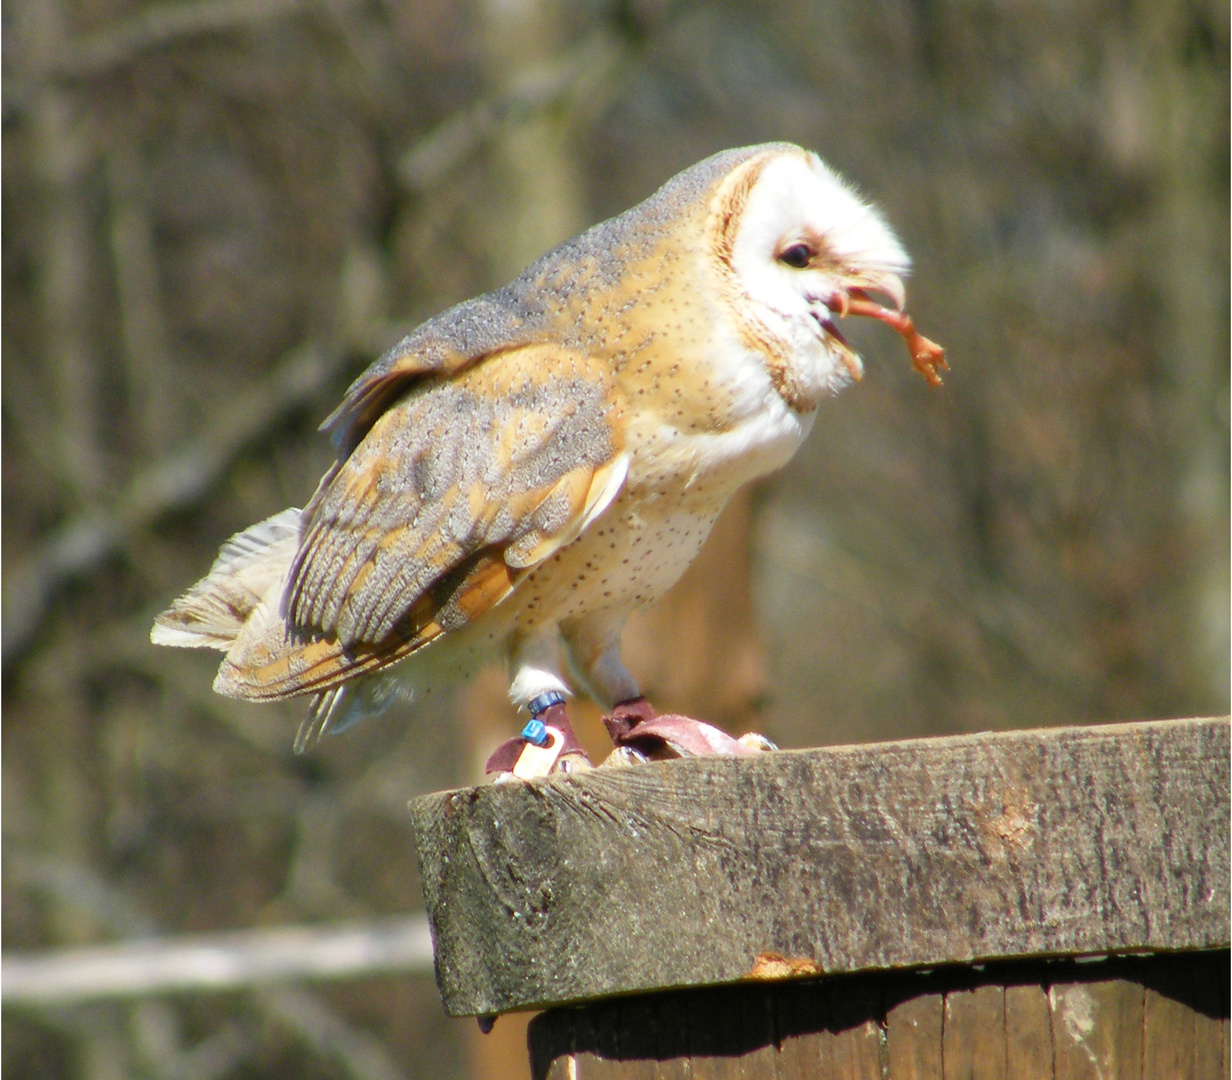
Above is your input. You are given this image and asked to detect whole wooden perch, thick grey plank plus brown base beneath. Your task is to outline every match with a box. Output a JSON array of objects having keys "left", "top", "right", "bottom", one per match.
[{"left": 411, "top": 718, "right": 1230, "bottom": 1080}]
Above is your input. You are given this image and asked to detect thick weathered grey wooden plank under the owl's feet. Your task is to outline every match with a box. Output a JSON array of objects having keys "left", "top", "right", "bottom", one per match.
[{"left": 411, "top": 719, "right": 1230, "bottom": 1016}]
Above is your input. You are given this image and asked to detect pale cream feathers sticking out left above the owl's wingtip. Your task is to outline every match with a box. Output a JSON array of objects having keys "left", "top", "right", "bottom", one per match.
[{"left": 150, "top": 507, "right": 299, "bottom": 653}]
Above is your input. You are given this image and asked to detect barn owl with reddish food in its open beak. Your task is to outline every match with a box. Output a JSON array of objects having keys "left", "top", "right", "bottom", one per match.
[{"left": 152, "top": 144, "right": 945, "bottom": 776}]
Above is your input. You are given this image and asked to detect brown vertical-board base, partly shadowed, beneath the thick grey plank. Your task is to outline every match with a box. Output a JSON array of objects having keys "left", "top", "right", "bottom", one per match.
[{"left": 529, "top": 951, "right": 1230, "bottom": 1080}]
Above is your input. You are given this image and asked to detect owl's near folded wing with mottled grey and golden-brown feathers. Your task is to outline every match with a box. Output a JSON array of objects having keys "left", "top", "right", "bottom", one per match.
[{"left": 216, "top": 345, "right": 628, "bottom": 698}]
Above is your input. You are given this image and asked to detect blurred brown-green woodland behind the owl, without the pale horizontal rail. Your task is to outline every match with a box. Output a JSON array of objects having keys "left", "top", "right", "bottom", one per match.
[{"left": 2, "top": 0, "right": 1230, "bottom": 1080}]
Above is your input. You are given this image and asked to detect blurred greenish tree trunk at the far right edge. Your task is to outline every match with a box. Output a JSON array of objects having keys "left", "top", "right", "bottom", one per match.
[{"left": 1133, "top": 2, "right": 1230, "bottom": 701}]
